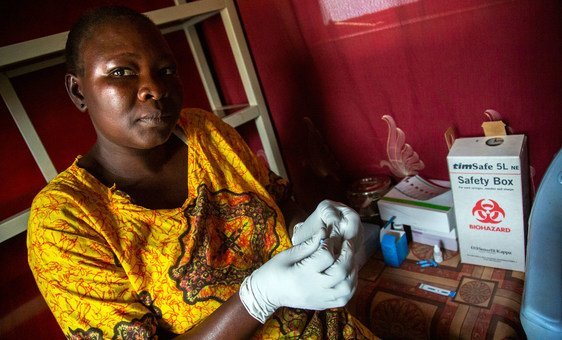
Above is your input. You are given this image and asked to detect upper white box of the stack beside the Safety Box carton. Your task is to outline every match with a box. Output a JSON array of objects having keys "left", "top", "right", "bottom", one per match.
[{"left": 378, "top": 176, "right": 456, "bottom": 234}]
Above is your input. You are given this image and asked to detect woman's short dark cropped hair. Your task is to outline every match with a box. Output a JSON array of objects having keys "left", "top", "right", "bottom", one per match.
[{"left": 65, "top": 6, "right": 156, "bottom": 75}]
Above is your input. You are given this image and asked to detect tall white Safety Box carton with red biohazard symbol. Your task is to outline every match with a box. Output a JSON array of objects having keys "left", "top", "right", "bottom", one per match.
[{"left": 447, "top": 135, "right": 529, "bottom": 271}]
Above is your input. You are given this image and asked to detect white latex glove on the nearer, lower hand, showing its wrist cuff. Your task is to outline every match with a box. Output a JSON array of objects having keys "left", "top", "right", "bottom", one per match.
[{"left": 239, "top": 228, "right": 357, "bottom": 323}]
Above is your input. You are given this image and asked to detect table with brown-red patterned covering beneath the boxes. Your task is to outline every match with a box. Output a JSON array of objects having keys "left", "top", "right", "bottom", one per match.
[{"left": 348, "top": 242, "right": 526, "bottom": 339}]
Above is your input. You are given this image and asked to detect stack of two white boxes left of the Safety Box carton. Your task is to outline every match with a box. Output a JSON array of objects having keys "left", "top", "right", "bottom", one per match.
[{"left": 378, "top": 176, "right": 458, "bottom": 251}]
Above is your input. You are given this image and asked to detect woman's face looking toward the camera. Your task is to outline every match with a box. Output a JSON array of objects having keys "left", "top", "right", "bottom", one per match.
[{"left": 76, "top": 22, "right": 182, "bottom": 149}]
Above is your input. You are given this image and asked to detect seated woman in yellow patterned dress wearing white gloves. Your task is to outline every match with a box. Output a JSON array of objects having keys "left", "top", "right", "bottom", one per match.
[{"left": 28, "top": 7, "right": 371, "bottom": 339}]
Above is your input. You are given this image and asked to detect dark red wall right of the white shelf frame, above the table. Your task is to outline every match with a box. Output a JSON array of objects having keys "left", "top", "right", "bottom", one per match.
[{"left": 230, "top": 0, "right": 562, "bottom": 209}]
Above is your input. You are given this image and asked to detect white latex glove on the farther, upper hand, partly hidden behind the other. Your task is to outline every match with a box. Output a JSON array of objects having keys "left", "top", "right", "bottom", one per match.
[{"left": 291, "top": 200, "right": 363, "bottom": 252}]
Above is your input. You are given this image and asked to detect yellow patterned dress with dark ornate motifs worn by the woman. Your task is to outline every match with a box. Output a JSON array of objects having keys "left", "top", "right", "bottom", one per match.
[{"left": 27, "top": 109, "right": 369, "bottom": 339}]
